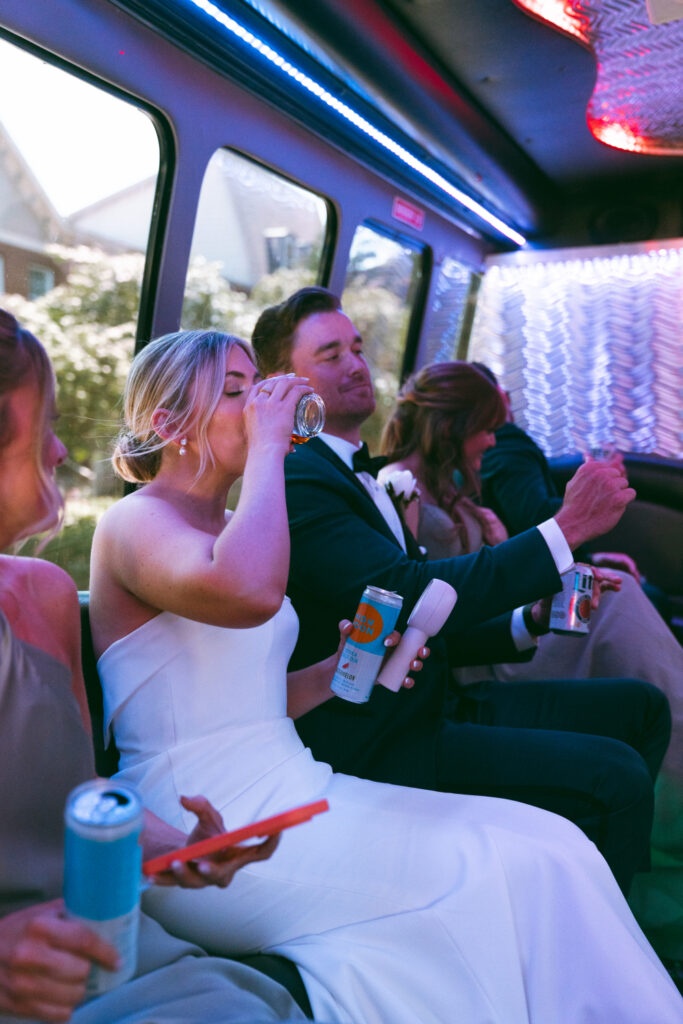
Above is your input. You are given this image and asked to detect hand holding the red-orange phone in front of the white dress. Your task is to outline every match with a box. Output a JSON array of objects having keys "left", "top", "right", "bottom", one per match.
[{"left": 151, "top": 797, "right": 280, "bottom": 889}]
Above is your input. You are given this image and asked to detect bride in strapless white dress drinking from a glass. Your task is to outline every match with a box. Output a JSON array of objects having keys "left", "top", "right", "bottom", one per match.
[{"left": 90, "top": 332, "right": 683, "bottom": 1024}]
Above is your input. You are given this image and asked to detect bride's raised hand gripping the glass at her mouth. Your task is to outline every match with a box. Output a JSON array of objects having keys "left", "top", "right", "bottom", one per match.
[{"left": 244, "top": 374, "right": 313, "bottom": 452}]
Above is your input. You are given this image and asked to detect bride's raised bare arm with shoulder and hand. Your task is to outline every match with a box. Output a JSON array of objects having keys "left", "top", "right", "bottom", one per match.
[{"left": 91, "top": 378, "right": 310, "bottom": 630}]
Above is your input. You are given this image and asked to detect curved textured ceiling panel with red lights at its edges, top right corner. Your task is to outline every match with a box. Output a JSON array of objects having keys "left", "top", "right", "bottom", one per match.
[{"left": 512, "top": 0, "right": 683, "bottom": 156}]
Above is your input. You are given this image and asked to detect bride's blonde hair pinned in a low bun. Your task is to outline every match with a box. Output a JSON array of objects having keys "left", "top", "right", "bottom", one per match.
[{"left": 112, "top": 331, "right": 254, "bottom": 483}]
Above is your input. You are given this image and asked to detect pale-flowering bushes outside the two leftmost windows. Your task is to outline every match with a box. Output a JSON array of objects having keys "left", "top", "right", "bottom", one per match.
[{"left": 2, "top": 246, "right": 321, "bottom": 479}]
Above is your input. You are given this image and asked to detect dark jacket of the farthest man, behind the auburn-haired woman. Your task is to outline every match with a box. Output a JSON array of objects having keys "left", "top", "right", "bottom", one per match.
[{"left": 481, "top": 423, "right": 562, "bottom": 536}]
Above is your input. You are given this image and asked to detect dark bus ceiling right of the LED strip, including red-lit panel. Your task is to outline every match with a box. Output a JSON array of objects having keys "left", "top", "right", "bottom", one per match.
[{"left": 214, "top": 0, "right": 683, "bottom": 246}]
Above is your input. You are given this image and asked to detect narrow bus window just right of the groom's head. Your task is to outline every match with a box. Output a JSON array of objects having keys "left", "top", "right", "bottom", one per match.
[{"left": 342, "top": 223, "right": 425, "bottom": 451}]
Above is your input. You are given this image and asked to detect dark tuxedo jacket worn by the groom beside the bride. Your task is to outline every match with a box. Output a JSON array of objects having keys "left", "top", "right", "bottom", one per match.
[{"left": 285, "top": 439, "right": 560, "bottom": 787}]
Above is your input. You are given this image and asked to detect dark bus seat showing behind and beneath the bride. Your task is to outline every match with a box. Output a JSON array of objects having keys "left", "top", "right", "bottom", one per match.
[{"left": 78, "top": 590, "right": 313, "bottom": 1020}]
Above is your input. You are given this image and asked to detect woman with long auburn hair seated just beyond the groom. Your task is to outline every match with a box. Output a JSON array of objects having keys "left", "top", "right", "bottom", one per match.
[{"left": 378, "top": 361, "right": 683, "bottom": 704}]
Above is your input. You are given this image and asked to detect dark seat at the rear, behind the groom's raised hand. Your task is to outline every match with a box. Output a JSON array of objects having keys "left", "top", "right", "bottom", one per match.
[{"left": 550, "top": 453, "right": 683, "bottom": 642}]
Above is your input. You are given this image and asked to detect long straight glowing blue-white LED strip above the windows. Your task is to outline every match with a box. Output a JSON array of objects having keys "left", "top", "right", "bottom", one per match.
[{"left": 179, "top": 0, "right": 526, "bottom": 246}]
